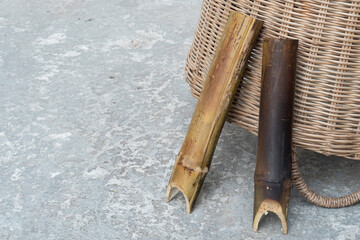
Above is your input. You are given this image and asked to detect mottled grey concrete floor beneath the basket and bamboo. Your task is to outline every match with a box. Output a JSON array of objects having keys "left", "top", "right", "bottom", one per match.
[{"left": 0, "top": 0, "right": 360, "bottom": 239}]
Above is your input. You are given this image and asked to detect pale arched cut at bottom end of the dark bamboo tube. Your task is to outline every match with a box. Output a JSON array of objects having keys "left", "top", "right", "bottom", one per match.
[{"left": 253, "top": 199, "right": 288, "bottom": 234}]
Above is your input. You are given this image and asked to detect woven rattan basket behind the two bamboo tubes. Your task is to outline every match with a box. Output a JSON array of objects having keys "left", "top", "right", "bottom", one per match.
[{"left": 186, "top": 0, "right": 360, "bottom": 206}]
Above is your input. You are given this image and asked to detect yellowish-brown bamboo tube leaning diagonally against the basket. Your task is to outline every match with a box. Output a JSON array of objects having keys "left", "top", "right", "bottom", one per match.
[{"left": 166, "top": 12, "right": 262, "bottom": 213}]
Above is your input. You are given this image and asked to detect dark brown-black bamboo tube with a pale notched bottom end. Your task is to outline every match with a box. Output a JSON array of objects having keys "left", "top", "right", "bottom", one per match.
[{"left": 253, "top": 38, "right": 298, "bottom": 234}]
